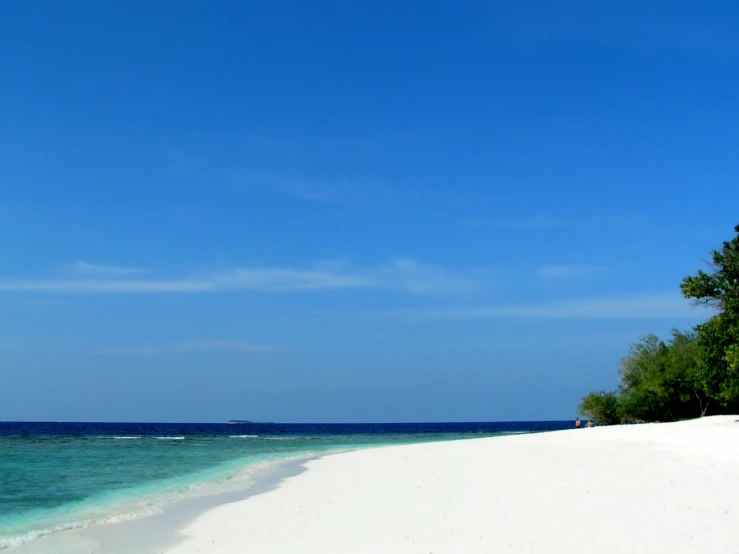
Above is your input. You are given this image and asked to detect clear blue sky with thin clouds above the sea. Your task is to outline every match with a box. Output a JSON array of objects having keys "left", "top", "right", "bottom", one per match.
[{"left": 0, "top": 0, "right": 739, "bottom": 421}]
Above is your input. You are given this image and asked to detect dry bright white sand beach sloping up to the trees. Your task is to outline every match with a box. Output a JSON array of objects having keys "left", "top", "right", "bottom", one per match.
[{"left": 167, "top": 416, "right": 739, "bottom": 554}]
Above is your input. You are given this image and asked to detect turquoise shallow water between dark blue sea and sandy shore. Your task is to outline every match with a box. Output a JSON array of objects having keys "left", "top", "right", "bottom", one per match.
[{"left": 0, "top": 437, "right": 324, "bottom": 548}]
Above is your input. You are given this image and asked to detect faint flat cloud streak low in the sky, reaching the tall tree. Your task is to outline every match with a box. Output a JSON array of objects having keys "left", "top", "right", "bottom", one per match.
[{"left": 395, "top": 294, "right": 709, "bottom": 320}]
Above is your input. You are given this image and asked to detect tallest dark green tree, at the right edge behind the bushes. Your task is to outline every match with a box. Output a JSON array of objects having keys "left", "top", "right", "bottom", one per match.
[{"left": 680, "top": 221, "right": 739, "bottom": 410}]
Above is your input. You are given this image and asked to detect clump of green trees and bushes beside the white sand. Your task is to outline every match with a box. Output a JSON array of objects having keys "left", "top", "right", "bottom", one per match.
[{"left": 580, "top": 225, "right": 739, "bottom": 425}]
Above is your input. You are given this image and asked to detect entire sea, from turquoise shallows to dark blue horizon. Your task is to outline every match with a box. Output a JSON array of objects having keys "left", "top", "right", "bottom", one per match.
[{"left": 0, "top": 421, "right": 572, "bottom": 550}]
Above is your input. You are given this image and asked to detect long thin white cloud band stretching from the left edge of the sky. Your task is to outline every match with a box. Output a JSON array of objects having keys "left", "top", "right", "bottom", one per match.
[{"left": 0, "top": 258, "right": 490, "bottom": 294}]
